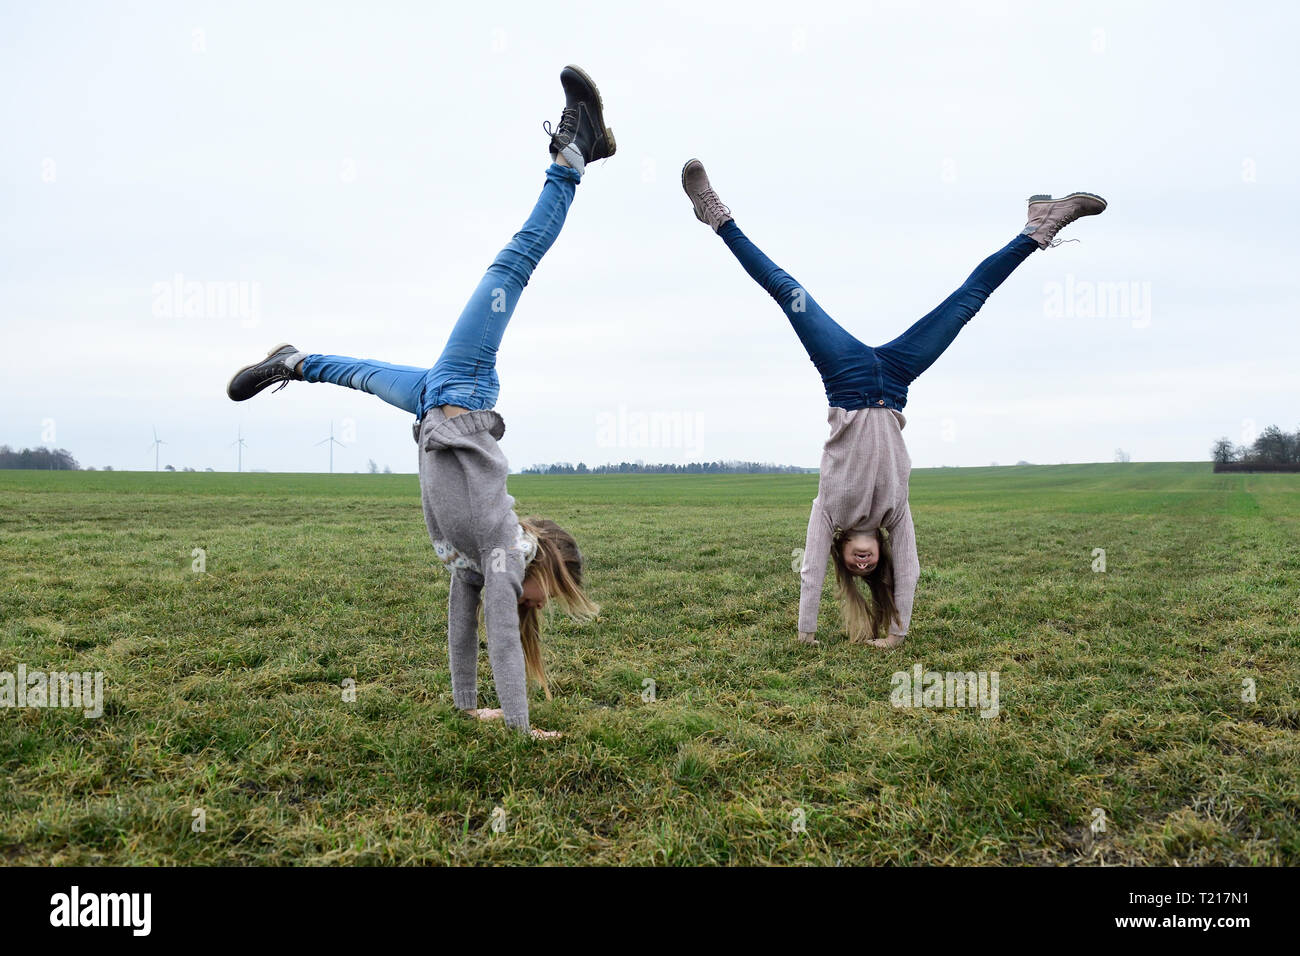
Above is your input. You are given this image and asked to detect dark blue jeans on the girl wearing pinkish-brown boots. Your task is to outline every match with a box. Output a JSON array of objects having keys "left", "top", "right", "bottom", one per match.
[{"left": 718, "top": 220, "right": 1039, "bottom": 411}]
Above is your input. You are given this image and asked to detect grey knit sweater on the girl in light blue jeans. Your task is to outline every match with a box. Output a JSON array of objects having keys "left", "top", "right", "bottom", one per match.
[{"left": 415, "top": 408, "right": 528, "bottom": 731}]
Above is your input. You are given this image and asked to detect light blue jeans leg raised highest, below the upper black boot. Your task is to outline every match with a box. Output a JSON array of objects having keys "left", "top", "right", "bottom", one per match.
[{"left": 417, "top": 163, "right": 582, "bottom": 418}]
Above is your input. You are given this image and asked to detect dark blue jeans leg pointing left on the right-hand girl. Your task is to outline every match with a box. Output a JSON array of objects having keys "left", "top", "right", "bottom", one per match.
[{"left": 718, "top": 220, "right": 880, "bottom": 408}]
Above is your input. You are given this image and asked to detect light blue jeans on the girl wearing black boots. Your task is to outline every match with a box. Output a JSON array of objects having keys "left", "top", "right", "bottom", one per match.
[{"left": 303, "top": 163, "right": 582, "bottom": 419}]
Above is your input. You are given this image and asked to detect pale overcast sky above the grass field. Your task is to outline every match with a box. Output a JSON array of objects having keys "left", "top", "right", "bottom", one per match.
[{"left": 0, "top": 0, "right": 1300, "bottom": 471}]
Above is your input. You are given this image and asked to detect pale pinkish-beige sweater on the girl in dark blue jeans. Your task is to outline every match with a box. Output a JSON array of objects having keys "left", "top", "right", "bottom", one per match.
[{"left": 798, "top": 406, "right": 920, "bottom": 635}]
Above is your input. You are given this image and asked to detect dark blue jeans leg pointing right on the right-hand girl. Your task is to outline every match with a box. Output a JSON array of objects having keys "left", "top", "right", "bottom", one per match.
[{"left": 876, "top": 235, "right": 1039, "bottom": 402}]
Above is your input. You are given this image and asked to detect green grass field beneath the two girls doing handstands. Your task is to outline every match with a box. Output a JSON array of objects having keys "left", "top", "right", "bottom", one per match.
[{"left": 0, "top": 464, "right": 1300, "bottom": 865}]
